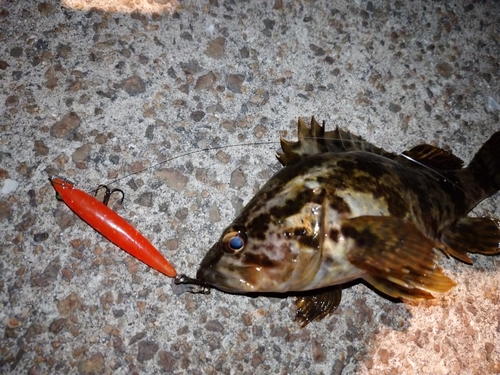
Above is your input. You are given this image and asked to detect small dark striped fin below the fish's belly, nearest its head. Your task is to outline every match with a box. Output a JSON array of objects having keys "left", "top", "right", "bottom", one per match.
[{"left": 295, "top": 286, "right": 342, "bottom": 328}]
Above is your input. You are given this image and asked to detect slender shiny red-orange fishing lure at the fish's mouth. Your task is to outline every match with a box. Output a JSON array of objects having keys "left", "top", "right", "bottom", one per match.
[{"left": 49, "top": 177, "right": 177, "bottom": 277}]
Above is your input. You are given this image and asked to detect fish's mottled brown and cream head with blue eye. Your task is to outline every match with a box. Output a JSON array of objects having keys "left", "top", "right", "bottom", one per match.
[{"left": 197, "top": 176, "right": 324, "bottom": 293}]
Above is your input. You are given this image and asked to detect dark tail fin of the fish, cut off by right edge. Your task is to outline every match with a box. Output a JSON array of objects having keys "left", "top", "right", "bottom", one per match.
[{"left": 467, "top": 131, "right": 500, "bottom": 198}]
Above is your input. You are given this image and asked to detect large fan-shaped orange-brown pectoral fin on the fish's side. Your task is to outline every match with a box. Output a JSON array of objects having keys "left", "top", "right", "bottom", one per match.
[{"left": 341, "top": 216, "right": 456, "bottom": 299}]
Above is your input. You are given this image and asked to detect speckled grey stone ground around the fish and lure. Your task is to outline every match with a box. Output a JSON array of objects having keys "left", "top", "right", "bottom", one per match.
[{"left": 0, "top": 0, "right": 500, "bottom": 374}]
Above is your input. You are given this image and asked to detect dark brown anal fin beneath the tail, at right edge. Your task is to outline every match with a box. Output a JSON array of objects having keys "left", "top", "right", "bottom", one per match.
[{"left": 442, "top": 217, "right": 500, "bottom": 264}]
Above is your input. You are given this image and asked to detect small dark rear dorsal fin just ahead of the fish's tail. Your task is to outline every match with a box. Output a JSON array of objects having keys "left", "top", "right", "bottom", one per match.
[{"left": 397, "top": 144, "right": 464, "bottom": 171}]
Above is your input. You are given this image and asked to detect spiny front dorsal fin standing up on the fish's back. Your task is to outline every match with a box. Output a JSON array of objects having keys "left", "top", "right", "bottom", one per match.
[{"left": 276, "top": 117, "right": 397, "bottom": 166}]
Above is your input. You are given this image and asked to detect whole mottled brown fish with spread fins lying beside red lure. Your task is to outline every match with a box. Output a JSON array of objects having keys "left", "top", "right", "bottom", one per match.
[{"left": 186, "top": 117, "right": 500, "bottom": 326}]
